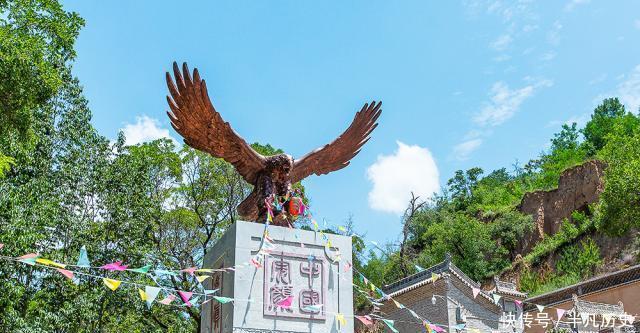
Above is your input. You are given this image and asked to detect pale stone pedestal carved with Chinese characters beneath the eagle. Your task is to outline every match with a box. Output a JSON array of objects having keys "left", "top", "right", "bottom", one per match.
[{"left": 201, "top": 221, "right": 353, "bottom": 333}]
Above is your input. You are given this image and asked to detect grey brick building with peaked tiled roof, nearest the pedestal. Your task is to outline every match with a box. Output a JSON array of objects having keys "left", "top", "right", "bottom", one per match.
[{"left": 380, "top": 255, "right": 526, "bottom": 333}]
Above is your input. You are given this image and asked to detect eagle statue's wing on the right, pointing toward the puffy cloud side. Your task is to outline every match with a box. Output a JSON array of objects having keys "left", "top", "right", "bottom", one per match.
[{"left": 291, "top": 101, "right": 382, "bottom": 183}]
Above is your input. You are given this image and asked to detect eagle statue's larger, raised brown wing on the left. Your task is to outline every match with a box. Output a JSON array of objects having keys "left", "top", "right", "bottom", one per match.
[{"left": 167, "top": 62, "right": 265, "bottom": 184}]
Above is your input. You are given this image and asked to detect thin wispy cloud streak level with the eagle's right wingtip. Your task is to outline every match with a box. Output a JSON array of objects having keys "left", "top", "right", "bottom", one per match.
[{"left": 473, "top": 78, "right": 552, "bottom": 126}]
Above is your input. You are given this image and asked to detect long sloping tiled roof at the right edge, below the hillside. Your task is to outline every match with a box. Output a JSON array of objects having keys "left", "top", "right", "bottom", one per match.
[{"left": 527, "top": 265, "right": 640, "bottom": 306}]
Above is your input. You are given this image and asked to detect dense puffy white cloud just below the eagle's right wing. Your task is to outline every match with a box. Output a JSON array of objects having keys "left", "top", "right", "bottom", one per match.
[{"left": 367, "top": 141, "right": 440, "bottom": 214}]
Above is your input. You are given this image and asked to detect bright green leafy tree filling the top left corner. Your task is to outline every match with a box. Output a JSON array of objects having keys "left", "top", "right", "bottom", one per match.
[{"left": 0, "top": 0, "right": 84, "bottom": 176}]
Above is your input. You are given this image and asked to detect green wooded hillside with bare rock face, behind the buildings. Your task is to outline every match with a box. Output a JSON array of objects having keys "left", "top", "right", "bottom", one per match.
[{"left": 360, "top": 98, "right": 640, "bottom": 294}]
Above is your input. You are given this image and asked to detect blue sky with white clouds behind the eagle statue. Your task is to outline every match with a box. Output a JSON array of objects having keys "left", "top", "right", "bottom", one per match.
[{"left": 64, "top": 0, "right": 640, "bottom": 246}]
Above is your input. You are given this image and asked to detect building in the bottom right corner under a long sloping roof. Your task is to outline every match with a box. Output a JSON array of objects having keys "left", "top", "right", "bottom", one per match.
[{"left": 524, "top": 265, "right": 640, "bottom": 333}]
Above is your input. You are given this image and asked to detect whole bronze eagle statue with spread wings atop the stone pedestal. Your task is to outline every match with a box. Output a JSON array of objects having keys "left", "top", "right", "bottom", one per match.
[{"left": 166, "top": 62, "right": 382, "bottom": 225}]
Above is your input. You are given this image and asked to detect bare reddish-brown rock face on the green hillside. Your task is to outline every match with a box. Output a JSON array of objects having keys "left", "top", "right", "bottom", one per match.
[{"left": 518, "top": 161, "right": 606, "bottom": 255}]
